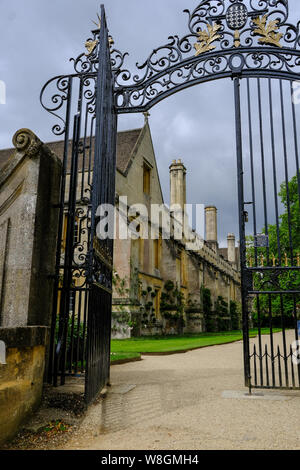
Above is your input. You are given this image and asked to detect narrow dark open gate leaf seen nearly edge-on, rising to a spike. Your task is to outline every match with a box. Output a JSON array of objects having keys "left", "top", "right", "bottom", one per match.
[{"left": 85, "top": 6, "right": 117, "bottom": 402}]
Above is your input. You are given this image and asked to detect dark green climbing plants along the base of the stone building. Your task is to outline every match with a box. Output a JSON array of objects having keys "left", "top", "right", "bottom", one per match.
[{"left": 113, "top": 273, "right": 240, "bottom": 335}]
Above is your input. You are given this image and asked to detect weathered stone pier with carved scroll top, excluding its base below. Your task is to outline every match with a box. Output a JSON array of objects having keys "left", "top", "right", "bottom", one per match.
[{"left": 0, "top": 129, "right": 62, "bottom": 327}]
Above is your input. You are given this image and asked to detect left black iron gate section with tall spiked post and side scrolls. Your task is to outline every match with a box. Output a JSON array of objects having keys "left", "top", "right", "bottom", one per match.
[{"left": 41, "top": 7, "right": 117, "bottom": 402}]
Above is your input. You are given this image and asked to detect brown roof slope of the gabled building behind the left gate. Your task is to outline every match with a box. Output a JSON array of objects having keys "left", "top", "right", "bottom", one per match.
[{"left": 0, "top": 128, "right": 143, "bottom": 174}]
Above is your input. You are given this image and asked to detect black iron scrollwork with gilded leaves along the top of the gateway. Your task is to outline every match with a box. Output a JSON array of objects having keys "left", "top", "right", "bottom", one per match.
[{"left": 41, "top": 0, "right": 300, "bottom": 119}]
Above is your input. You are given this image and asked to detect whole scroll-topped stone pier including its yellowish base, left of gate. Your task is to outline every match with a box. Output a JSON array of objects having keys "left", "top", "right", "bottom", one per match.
[{"left": 0, "top": 129, "right": 61, "bottom": 443}]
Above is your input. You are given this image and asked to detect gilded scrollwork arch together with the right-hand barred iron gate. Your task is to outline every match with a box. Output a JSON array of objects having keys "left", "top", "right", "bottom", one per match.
[{"left": 110, "top": 0, "right": 300, "bottom": 389}]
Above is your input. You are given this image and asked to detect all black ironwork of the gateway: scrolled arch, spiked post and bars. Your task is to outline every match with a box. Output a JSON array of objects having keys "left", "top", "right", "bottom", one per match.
[{"left": 41, "top": 0, "right": 300, "bottom": 401}]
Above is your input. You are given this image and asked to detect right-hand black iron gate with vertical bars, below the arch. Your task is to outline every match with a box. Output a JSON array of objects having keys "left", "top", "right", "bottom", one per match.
[{"left": 234, "top": 78, "right": 300, "bottom": 389}]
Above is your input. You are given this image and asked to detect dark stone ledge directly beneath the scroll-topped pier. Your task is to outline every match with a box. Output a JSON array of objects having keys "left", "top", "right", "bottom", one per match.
[{"left": 0, "top": 326, "right": 50, "bottom": 348}]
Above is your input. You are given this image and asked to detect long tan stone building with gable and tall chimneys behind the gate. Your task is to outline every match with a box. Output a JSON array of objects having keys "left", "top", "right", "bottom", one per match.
[{"left": 0, "top": 117, "right": 240, "bottom": 337}]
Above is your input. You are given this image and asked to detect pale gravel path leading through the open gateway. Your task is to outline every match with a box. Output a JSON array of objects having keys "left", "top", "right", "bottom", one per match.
[{"left": 66, "top": 332, "right": 300, "bottom": 450}]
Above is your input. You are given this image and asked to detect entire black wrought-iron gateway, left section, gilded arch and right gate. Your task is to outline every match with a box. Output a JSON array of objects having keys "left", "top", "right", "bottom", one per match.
[{"left": 41, "top": 0, "right": 300, "bottom": 401}]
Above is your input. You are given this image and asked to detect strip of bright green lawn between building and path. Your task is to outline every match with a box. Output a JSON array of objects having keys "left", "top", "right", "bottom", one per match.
[{"left": 111, "top": 328, "right": 280, "bottom": 361}]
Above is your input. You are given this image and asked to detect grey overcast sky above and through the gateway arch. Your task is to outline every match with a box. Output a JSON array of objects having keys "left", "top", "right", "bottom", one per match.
[{"left": 0, "top": 0, "right": 300, "bottom": 245}]
